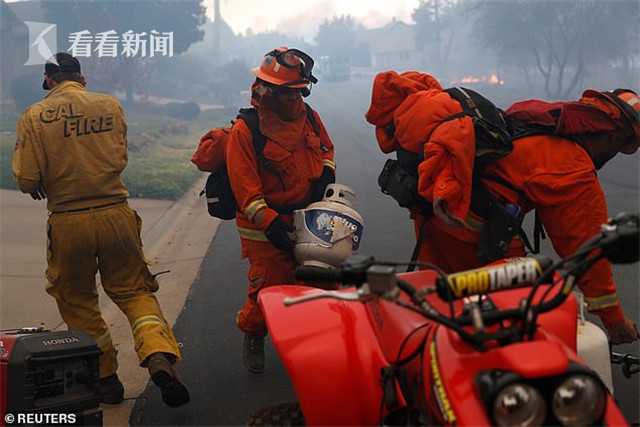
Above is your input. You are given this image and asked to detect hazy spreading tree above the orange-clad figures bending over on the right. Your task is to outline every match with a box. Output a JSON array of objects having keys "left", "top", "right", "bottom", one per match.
[{"left": 476, "top": 0, "right": 640, "bottom": 98}]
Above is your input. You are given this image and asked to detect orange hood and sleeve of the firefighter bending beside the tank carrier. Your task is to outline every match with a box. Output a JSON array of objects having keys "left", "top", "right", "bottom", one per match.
[{"left": 366, "top": 71, "right": 475, "bottom": 224}]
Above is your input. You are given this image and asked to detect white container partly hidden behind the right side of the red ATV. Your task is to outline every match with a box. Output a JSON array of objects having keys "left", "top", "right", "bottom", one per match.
[{"left": 576, "top": 292, "right": 613, "bottom": 394}]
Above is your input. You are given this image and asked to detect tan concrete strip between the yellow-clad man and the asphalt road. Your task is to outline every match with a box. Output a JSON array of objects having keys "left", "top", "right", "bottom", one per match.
[{"left": 102, "top": 175, "right": 220, "bottom": 426}]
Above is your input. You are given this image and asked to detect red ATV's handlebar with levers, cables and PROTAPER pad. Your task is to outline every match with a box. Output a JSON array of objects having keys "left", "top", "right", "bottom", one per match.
[{"left": 292, "top": 214, "right": 640, "bottom": 350}]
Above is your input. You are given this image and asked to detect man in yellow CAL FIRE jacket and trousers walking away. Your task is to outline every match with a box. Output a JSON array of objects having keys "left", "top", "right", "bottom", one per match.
[{"left": 12, "top": 53, "right": 189, "bottom": 406}]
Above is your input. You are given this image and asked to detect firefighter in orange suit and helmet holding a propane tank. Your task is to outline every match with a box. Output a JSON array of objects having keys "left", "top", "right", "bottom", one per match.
[{"left": 226, "top": 47, "right": 335, "bottom": 373}]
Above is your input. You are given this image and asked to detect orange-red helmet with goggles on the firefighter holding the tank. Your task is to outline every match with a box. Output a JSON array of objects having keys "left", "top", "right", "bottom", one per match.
[{"left": 253, "top": 47, "right": 318, "bottom": 89}]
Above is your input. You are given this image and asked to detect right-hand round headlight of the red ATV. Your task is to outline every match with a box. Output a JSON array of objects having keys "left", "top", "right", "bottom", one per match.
[{"left": 553, "top": 375, "right": 606, "bottom": 426}]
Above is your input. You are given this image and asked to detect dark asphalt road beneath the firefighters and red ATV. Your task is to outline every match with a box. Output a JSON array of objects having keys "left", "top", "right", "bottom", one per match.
[{"left": 131, "top": 79, "right": 639, "bottom": 425}]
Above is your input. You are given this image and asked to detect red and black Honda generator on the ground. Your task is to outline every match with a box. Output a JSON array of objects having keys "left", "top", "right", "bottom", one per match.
[{"left": 0, "top": 328, "right": 102, "bottom": 426}]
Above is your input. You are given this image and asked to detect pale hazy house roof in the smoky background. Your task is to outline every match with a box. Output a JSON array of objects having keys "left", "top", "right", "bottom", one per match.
[{"left": 357, "top": 19, "right": 416, "bottom": 54}]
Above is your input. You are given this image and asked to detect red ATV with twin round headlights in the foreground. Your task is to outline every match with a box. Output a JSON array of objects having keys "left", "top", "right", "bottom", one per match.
[{"left": 249, "top": 215, "right": 640, "bottom": 426}]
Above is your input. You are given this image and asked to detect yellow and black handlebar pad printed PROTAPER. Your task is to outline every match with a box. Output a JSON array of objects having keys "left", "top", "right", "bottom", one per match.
[{"left": 436, "top": 257, "right": 552, "bottom": 301}]
